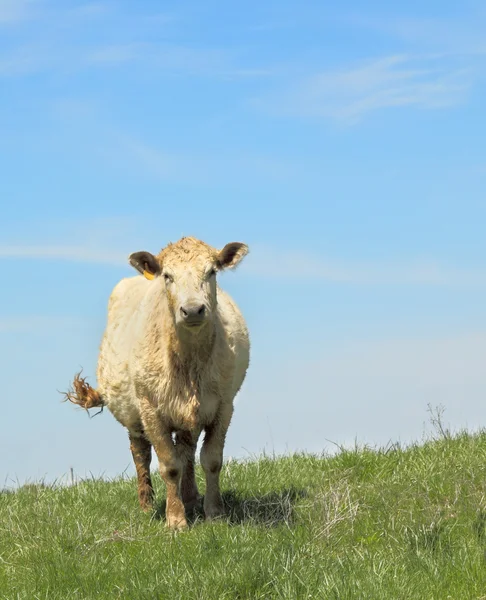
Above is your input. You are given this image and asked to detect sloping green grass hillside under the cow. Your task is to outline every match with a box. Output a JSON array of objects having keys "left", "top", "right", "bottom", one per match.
[{"left": 0, "top": 432, "right": 486, "bottom": 600}]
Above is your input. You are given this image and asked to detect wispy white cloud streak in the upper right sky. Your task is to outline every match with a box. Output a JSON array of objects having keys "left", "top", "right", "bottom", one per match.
[{"left": 254, "top": 55, "right": 473, "bottom": 124}]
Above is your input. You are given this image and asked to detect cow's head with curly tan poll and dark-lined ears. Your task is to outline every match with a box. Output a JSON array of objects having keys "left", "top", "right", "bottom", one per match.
[{"left": 129, "top": 237, "right": 248, "bottom": 332}]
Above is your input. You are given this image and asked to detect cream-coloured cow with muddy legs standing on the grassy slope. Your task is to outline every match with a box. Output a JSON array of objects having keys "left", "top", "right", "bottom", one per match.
[{"left": 65, "top": 237, "right": 250, "bottom": 530}]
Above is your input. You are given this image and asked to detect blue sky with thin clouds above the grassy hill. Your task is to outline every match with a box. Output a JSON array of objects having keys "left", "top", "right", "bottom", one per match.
[{"left": 0, "top": 0, "right": 486, "bottom": 485}]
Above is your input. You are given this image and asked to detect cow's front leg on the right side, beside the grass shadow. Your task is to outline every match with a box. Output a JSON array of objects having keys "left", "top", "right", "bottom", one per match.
[{"left": 201, "top": 404, "right": 233, "bottom": 519}]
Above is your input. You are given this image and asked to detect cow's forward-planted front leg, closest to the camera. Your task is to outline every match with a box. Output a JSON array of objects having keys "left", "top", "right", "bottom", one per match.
[{"left": 140, "top": 398, "right": 187, "bottom": 529}]
